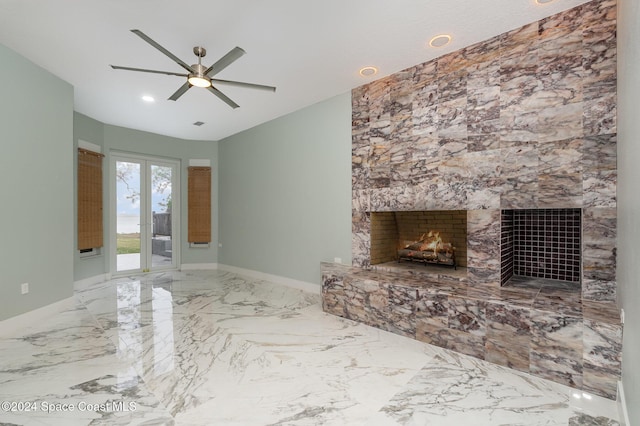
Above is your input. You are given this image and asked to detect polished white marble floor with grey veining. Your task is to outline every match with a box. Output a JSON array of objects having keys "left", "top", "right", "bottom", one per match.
[{"left": 0, "top": 271, "right": 618, "bottom": 426}]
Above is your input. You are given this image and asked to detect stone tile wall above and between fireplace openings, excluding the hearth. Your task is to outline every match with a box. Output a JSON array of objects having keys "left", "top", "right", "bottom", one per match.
[{"left": 352, "top": 0, "right": 617, "bottom": 302}]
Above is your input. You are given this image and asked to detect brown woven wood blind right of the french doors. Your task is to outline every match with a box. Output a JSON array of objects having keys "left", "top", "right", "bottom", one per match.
[{"left": 188, "top": 167, "right": 211, "bottom": 243}]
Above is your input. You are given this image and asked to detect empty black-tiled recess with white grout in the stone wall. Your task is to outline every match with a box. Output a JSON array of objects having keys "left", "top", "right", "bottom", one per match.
[{"left": 500, "top": 209, "right": 582, "bottom": 290}]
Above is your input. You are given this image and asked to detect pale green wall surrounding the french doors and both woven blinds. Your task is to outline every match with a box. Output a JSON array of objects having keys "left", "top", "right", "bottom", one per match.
[{"left": 74, "top": 113, "right": 218, "bottom": 280}]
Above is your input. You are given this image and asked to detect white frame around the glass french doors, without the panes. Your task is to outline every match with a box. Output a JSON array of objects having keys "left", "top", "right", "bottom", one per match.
[{"left": 108, "top": 151, "right": 182, "bottom": 276}]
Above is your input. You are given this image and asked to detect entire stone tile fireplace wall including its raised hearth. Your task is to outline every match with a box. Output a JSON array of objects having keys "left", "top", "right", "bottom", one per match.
[{"left": 322, "top": 0, "right": 622, "bottom": 398}]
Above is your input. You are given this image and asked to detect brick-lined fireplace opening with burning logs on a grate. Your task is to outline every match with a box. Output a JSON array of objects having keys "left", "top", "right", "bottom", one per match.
[{"left": 371, "top": 210, "right": 467, "bottom": 267}]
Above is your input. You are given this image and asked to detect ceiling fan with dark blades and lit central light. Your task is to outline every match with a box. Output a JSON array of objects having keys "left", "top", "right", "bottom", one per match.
[{"left": 111, "top": 30, "right": 276, "bottom": 108}]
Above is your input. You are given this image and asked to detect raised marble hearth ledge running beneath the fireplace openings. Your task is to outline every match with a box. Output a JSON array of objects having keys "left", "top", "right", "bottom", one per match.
[{"left": 321, "top": 263, "right": 622, "bottom": 399}]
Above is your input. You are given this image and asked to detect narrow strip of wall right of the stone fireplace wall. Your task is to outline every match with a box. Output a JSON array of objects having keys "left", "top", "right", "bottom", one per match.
[{"left": 617, "top": 0, "right": 640, "bottom": 425}]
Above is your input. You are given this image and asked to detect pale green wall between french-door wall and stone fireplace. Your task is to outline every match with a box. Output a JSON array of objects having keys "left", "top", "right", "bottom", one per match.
[{"left": 219, "top": 94, "right": 351, "bottom": 283}]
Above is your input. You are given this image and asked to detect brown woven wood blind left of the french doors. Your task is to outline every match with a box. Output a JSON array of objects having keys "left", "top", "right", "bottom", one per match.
[{"left": 78, "top": 148, "right": 104, "bottom": 250}]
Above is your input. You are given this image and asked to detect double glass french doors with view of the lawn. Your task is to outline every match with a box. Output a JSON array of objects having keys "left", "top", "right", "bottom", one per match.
[{"left": 111, "top": 154, "right": 180, "bottom": 274}]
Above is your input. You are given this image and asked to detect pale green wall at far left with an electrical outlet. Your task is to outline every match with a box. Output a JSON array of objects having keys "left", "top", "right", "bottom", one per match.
[{"left": 0, "top": 45, "right": 74, "bottom": 320}]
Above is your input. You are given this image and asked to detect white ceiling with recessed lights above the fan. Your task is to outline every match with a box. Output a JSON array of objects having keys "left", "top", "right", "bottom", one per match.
[{"left": 0, "top": 0, "right": 587, "bottom": 140}]
